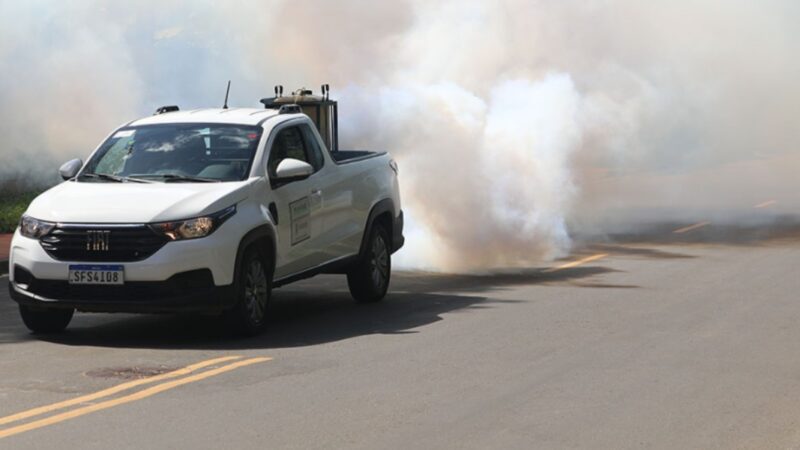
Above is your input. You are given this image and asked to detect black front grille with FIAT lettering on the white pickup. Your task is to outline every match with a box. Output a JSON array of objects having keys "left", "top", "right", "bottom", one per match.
[{"left": 40, "top": 224, "right": 169, "bottom": 262}]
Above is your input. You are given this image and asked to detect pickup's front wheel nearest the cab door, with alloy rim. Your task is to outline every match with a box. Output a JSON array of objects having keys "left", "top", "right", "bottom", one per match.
[{"left": 225, "top": 246, "right": 273, "bottom": 336}]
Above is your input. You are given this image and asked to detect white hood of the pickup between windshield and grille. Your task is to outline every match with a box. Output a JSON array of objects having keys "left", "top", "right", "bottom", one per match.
[{"left": 26, "top": 181, "right": 251, "bottom": 223}]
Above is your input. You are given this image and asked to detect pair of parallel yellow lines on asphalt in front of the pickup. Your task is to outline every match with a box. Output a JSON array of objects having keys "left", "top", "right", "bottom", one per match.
[{"left": 0, "top": 356, "right": 272, "bottom": 439}]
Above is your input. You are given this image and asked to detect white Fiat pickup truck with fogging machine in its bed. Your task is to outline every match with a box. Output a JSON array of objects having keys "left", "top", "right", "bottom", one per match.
[{"left": 9, "top": 87, "right": 404, "bottom": 335}]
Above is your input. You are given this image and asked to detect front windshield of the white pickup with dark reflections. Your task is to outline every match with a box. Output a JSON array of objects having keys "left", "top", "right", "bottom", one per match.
[{"left": 79, "top": 123, "right": 262, "bottom": 182}]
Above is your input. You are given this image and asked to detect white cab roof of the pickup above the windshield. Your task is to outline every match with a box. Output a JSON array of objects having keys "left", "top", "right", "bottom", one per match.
[{"left": 128, "top": 108, "right": 278, "bottom": 127}]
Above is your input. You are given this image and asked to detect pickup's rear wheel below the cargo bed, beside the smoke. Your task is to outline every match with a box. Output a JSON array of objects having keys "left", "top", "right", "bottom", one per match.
[{"left": 347, "top": 225, "right": 392, "bottom": 303}]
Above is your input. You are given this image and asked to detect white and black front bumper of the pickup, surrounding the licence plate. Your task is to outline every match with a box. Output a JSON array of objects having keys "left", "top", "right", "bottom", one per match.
[{"left": 8, "top": 231, "right": 236, "bottom": 313}]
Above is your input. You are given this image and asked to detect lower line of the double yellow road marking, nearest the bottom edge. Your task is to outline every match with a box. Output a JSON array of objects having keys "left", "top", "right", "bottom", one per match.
[{"left": 0, "top": 357, "right": 272, "bottom": 439}]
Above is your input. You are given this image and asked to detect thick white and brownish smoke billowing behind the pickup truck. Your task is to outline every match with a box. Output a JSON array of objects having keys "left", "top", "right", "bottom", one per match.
[{"left": 0, "top": 0, "right": 800, "bottom": 270}]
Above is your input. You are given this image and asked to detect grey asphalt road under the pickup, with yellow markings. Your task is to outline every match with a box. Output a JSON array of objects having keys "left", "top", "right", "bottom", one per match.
[{"left": 0, "top": 225, "right": 800, "bottom": 449}]
